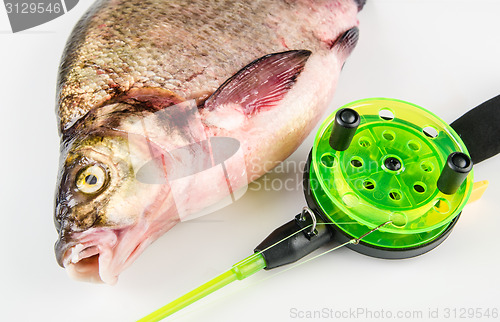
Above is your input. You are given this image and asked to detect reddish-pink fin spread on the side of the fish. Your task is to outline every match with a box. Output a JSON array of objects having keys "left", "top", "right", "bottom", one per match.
[{"left": 204, "top": 50, "right": 311, "bottom": 115}]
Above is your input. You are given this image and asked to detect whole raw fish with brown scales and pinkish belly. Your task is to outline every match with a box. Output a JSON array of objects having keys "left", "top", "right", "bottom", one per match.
[{"left": 54, "top": 0, "right": 364, "bottom": 284}]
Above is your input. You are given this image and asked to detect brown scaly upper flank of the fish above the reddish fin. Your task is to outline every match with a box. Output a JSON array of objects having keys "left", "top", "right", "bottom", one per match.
[{"left": 58, "top": 0, "right": 352, "bottom": 131}]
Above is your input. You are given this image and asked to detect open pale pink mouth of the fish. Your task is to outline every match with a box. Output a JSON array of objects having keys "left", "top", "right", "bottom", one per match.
[{"left": 55, "top": 226, "right": 150, "bottom": 285}]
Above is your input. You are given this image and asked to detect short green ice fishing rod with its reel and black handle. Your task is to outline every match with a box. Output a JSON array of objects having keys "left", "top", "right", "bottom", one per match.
[{"left": 139, "top": 96, "right": 500, "bottom": 322}]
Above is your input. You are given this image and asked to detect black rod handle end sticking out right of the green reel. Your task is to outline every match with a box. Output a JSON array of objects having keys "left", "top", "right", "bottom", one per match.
[{"left": 450, "top": 95, "right": 500, "bottom": 164}]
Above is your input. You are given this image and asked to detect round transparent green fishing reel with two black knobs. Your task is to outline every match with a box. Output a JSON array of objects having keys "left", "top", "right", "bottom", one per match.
[{"left": 304, "top": 98, "right": 473, "bottom": 258}]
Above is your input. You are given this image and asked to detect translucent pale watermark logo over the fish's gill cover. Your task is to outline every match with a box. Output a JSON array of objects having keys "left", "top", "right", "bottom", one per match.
[{"left": 128, "top": 100, "right": 248, "bottom": 221}]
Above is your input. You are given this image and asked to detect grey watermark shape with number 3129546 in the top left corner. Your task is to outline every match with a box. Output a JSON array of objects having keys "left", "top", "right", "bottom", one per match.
[{"left": 4, "top": 0, "right": 78, "bottom": 33}]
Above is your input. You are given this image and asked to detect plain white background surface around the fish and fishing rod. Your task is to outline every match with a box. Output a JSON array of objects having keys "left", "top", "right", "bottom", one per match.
[{"left": 0, "top": 0, "right": 500, "bottom": 322}]
